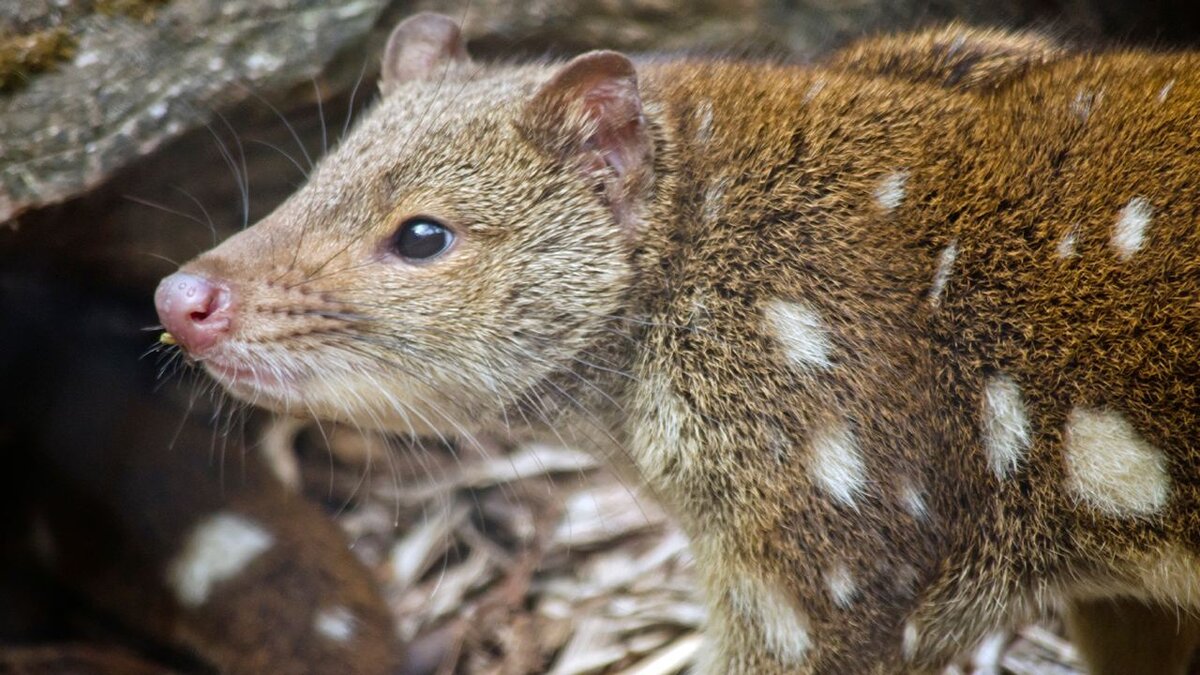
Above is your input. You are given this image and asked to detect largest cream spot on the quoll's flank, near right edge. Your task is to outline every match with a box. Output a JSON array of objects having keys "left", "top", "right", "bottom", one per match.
[{"left": 1064, "top": 407, "right": 1171, "bottom": 515}]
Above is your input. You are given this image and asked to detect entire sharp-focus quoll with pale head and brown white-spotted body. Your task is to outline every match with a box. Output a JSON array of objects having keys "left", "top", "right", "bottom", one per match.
[{"left": 157, "top": 14, "right": 1200, "bottom": 673}]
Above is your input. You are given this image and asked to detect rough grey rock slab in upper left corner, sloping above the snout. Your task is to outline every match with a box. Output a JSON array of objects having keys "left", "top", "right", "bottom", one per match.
[{"left": 0, "top": 0, "right": 384, "bottom": 221}]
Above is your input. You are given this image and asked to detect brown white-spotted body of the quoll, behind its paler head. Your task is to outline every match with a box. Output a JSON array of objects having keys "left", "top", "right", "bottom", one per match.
[{"left": 634, "top": 40, "right": 1200, "bottom": 673}]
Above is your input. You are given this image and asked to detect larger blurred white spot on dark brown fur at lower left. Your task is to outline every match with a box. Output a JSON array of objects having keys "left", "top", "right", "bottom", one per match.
[{"left": 167, "top": 513, "right": 275, "bottom": 608}]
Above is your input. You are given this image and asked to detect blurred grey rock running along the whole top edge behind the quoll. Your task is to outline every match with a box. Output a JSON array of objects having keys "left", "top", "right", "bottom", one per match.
[{"left": 0, "top": 0, "right": 1198, "bottom": 228}]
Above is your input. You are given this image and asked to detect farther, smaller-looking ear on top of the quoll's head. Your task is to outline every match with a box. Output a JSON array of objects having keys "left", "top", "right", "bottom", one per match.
[{"left": 379, "top": 12, "right": 470, "bottom": 94}]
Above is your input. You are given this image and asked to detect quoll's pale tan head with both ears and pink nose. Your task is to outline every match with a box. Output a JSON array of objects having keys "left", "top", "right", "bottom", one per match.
[{"left": 155, "top": 14, "right": 653, "bottom": 431}]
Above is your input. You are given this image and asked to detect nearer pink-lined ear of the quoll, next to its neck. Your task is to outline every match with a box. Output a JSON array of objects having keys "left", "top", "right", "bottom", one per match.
[{"left": 527, "top": 52, "right": 654, "bottom": 233}]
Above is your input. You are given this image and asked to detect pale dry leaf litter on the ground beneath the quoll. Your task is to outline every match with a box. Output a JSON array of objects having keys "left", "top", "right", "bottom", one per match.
[{"left": 262, "top": 420, "right": 1084, "bottom": 675}]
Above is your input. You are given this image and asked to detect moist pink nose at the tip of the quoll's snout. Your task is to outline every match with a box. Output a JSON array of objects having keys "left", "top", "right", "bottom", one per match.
[{"left": 154, "top": 271, "right": 234, "bottom": 356}]
